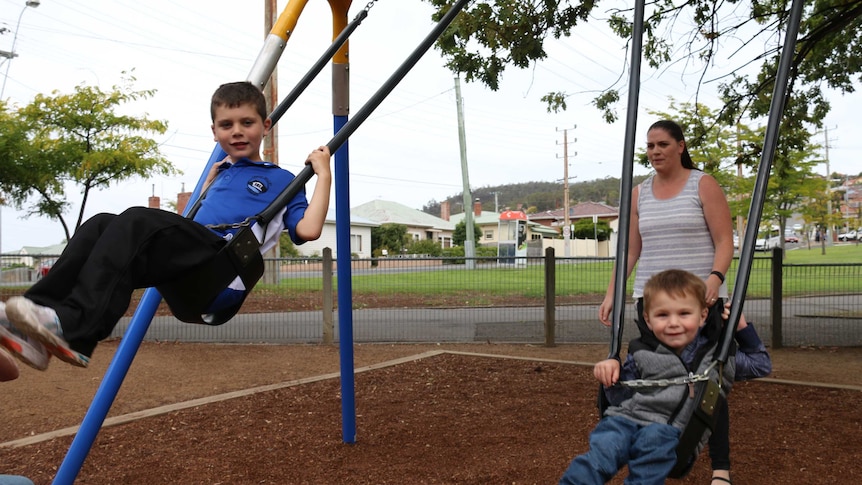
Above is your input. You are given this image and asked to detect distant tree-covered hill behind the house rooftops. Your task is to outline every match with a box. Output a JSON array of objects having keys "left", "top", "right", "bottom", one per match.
[{"left": 422, "top": 175, "right": 647, "bottom": 216}]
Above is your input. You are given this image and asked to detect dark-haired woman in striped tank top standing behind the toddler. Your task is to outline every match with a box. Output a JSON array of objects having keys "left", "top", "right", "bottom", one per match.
[{"left": 599, "top": 120, "right": 733, "bottom": 485}]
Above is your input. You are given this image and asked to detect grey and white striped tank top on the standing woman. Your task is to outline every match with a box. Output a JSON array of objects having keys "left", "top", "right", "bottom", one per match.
[{"left": 632, "top": 170, "right": 727, "bottom": 298}]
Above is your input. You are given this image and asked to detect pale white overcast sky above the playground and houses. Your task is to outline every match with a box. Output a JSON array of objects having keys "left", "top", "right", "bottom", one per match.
[{"left": 0, "top": 0, "right": 862, "bottom": 252}]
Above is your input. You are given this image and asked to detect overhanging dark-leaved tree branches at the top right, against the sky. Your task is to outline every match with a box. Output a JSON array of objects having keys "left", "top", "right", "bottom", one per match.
[{"left": 426, "top": 0, "right": 862, "bottom": 126}]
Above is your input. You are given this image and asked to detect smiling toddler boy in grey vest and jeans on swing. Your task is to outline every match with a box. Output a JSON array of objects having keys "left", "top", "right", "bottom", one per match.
[{"left": 560, "top": 269, "right": 771, "bottom": 485}]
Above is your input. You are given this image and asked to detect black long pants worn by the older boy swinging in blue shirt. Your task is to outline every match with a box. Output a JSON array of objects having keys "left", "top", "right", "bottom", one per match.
[{"left": 24, "top": 207, "right": 225, "bottom": 356}]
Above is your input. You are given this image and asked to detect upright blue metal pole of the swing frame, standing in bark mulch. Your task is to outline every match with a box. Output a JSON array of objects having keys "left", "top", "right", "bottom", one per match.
[{"left": 333, "top": 116, "right": 356, "bottom": 444}]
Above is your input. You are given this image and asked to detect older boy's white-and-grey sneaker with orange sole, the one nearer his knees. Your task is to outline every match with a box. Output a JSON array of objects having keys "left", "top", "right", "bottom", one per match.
[{"left": 6, "top": 296, "right": 90, "bottom": 367}]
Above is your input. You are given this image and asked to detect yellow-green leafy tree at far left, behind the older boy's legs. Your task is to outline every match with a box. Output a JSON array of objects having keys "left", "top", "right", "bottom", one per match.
[{"left": 0, "top": 77, "right": 177, "bottom": 240}]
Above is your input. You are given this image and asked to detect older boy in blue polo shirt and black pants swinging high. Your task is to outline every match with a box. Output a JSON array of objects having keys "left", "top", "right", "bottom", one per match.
[{"left": 0, "top": 82, "right": 332, "bottom": 370}]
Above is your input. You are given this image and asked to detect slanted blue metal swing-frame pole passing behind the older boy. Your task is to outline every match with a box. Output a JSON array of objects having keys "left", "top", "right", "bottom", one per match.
[{"left": 54, "top": 145, "right": 225, "bottom": 485}]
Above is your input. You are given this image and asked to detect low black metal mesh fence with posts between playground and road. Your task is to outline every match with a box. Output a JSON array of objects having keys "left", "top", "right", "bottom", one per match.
[{"left": 0, "top": 251, "right": 862, "bottom": 347}]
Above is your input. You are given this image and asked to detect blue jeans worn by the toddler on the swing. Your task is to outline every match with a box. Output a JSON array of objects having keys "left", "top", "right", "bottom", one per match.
[{"left": 560, "top": 416, "right": 680, "bottom": 485}]
